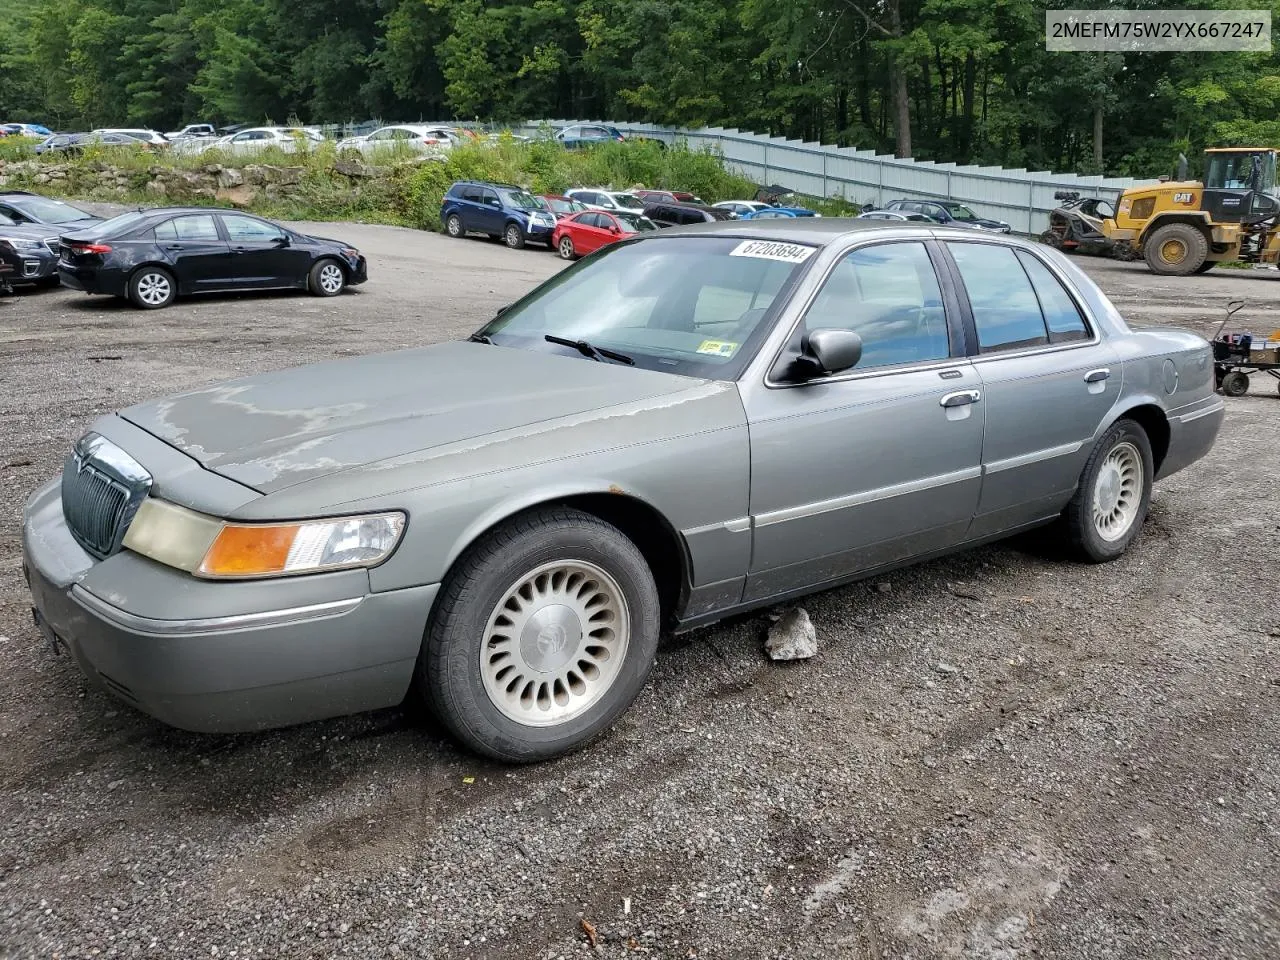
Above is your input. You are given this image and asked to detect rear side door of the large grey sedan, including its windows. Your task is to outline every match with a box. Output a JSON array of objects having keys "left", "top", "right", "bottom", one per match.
[{"left": 945, "top": 241, "right": 1123, "bottom": 536}]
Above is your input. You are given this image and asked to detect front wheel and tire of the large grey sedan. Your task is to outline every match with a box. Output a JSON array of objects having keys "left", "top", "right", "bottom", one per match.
[{"left": 416, "top": 508, "right": 660, "bottom": 763}]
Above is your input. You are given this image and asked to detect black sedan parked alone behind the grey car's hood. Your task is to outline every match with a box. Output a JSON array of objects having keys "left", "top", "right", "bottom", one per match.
[{"left": 58, "top": 207, "right": 369, "bottom": 310}]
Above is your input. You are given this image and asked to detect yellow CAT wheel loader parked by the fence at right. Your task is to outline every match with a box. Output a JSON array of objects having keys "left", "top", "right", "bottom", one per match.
[{"left": 1102, "top": 147, "right": 1280, "bottom": 276}]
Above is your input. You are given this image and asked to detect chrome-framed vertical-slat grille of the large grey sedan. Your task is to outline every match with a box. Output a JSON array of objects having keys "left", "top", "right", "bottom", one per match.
[{"left": 63, "top": 434, "right": 151, "bottom": 559}]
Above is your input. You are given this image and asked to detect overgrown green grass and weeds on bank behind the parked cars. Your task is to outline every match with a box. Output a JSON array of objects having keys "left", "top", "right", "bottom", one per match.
[{"left": 0, "top": 137, "right": 778, "bottom": 230}]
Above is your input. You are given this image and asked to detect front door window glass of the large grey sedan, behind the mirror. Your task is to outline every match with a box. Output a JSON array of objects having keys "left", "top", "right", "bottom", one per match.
[{"left": 794, "top": 243, "right": 951, "bottom": 370}]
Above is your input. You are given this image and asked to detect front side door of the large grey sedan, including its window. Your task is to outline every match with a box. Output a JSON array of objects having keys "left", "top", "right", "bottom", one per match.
[{"left": 745, "top": 241, "right": 986, "bottom": 600}]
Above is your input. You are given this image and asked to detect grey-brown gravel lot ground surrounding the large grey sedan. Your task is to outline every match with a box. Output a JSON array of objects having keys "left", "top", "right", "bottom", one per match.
[{"left": 0, "top": 224, "right": 1280, "bottom": 960}]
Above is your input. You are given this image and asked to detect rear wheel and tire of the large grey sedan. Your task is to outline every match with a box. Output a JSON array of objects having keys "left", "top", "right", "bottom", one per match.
[{"left": 1062, "top": 420, "right": 1156, "bottom": 563}]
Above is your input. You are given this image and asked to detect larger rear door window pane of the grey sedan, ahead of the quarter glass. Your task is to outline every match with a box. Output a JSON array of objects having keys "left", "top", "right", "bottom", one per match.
[{"left": 947, "top": 242, "right": 1048, "bottom": 353}]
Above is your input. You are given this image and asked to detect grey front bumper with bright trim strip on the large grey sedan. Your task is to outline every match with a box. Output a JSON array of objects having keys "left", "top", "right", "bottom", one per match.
[{"left": 22, "top": 481, "right": 438, "bottom": 732}]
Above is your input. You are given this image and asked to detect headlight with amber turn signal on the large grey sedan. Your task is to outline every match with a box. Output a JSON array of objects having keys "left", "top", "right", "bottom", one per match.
[{"left": 124, "top": 498, "right": 404, "bottom": 580}]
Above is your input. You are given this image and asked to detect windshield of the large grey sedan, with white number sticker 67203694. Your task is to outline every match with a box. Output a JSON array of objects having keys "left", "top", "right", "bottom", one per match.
[{"left": 479, "top": 236, "right": 817, "bottom": 380}]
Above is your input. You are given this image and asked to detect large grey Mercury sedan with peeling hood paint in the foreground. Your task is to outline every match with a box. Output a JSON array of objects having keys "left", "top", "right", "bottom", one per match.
[{"left": 23, "top": 219, "right": 1222, "bottom": 762}]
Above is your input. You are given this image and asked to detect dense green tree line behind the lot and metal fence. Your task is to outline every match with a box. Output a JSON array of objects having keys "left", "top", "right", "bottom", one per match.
[{"left": 0, "top": 0, "right": 1280, "bottom": 177}]
